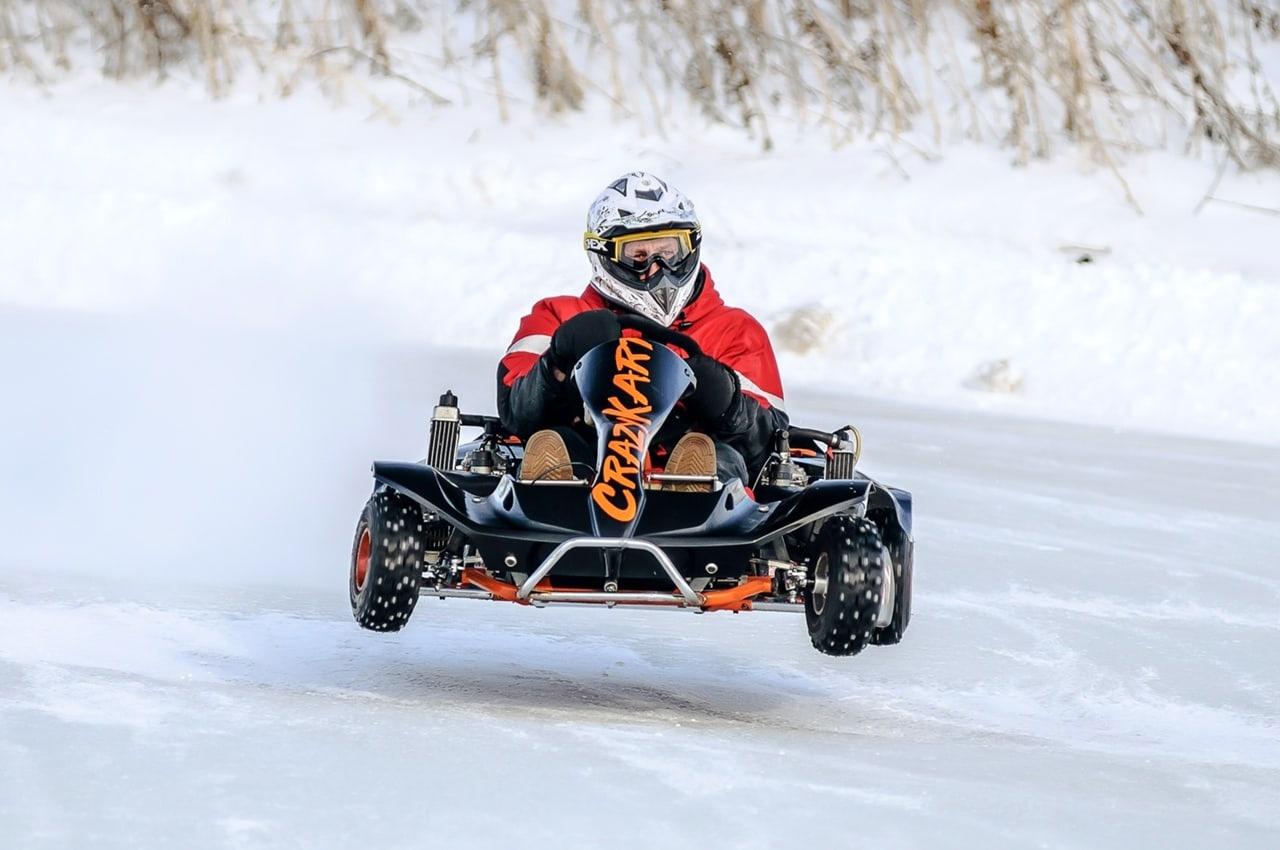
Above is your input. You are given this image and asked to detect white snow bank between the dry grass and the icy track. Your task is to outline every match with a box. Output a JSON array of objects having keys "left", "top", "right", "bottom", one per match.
[{"left": 0, "top": 82, "right": 1280, "bottom": 442}]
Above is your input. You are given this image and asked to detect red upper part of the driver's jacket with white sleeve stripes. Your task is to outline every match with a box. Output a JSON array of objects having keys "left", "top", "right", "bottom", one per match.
[{"left": 498, "top": 265, "right": 786, "bottom": 412}]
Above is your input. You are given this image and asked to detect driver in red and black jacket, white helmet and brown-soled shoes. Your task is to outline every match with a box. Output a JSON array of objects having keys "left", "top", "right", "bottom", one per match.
[{"left": 498, "top": 172, "right": 787, "bottom": 490}]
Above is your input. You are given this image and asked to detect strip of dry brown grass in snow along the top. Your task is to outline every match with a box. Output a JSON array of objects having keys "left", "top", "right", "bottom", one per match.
[{"left": 0, "top": 0, "right": 1280, "bottom": 171}]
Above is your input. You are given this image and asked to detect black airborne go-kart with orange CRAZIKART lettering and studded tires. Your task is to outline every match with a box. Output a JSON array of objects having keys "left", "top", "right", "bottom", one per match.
[{"left": 349, "top": 316, "right": 914, "bottom": 655}]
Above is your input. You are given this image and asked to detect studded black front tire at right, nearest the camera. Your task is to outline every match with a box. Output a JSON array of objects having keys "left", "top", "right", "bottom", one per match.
[{"left": 804, "top": 517, "right": 884, "bottom": 655}]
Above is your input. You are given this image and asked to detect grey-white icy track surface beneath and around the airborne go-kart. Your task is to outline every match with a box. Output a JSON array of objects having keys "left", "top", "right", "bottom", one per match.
[{"left": 0, "top": 319, "right": 1280, "bottom": 849}]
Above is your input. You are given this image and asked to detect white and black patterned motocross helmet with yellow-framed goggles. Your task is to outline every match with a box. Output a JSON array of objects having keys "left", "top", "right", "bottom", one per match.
[{"left": 582, "top": 172, "right": 703, "bottom": 325}]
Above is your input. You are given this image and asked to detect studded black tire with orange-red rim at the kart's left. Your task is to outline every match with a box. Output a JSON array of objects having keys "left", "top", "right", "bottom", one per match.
[{"left": 349, "top": 490, "right": 425, "bottom": 631}]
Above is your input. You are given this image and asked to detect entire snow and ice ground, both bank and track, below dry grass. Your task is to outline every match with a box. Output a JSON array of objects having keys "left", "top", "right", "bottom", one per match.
[{"left": 0, "top": 72, "right": 1280, "bottom": 847}]
